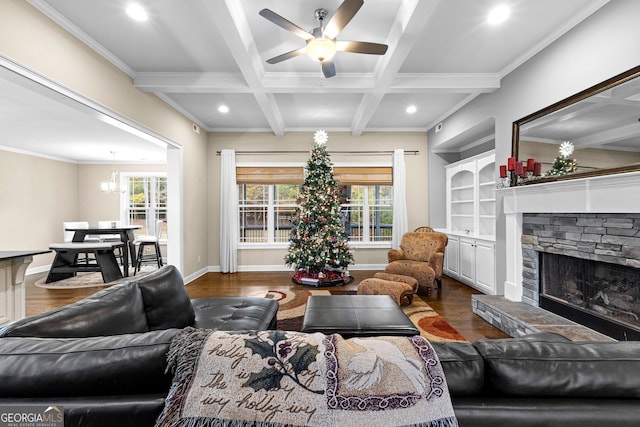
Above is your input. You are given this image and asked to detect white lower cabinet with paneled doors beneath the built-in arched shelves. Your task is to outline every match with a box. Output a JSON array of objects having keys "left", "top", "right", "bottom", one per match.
[{"left": 444, "top": 234, "right": 497, "bottom": 295}]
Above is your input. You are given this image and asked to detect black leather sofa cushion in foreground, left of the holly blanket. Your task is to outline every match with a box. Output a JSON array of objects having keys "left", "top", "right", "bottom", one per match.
[{"left": 0, "top": 329, "right": 180, "bottom": 397}]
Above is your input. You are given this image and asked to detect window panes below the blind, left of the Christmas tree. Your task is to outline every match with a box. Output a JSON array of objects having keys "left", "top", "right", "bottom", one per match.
[{"left": 238, "top": 184, "right": 299, "bottom": 243}]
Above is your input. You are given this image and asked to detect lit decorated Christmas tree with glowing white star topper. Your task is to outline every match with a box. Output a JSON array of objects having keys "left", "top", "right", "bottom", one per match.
[{"left": 285, "top": 131, "right": 353, "bottom": 284}]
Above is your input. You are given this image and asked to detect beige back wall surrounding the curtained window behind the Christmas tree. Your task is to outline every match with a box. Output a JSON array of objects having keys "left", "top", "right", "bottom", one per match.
[{"left": 207, "top": 132, "right": 430, "bottom": 269}]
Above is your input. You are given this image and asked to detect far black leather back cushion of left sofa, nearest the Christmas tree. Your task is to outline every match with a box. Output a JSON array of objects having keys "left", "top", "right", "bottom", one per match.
[{"left": 135, "top": 265, "right": 196, "bottom": 331}]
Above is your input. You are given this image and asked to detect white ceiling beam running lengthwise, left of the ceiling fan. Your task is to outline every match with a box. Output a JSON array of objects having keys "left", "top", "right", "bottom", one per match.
[{"left": 198, "top": 0, "right": 284, "bottom": 136}]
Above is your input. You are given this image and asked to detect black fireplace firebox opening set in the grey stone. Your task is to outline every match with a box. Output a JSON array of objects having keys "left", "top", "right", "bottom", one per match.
[{"left": 539, "top": 252, "right": 640, "bottom": 341}]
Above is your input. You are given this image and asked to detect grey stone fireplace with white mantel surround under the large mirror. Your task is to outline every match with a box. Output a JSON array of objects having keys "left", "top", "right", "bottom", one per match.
[{"left": 497, "top": 172, "right": 640, "bottom": 340}]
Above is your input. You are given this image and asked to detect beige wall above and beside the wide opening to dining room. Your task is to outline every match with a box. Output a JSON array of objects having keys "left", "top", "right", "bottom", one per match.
[{"left": 0, "top": 0, "right": 207, "bottom": 275}]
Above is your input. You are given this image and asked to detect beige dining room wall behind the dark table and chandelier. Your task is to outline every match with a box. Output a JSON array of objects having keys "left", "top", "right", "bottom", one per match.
[{"left": 0, "top": 150, "right": 166, "bottom": 269}]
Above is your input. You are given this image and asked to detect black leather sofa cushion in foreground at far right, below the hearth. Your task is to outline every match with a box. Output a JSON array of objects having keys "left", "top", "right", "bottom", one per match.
[{"left": 473, "top": 337, "right": 640, "bottom": 399}]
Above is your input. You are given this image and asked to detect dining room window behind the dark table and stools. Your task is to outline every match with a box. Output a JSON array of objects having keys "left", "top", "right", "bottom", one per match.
[{"left": 123, "top": 174, "right": 168, "bottom": 239}]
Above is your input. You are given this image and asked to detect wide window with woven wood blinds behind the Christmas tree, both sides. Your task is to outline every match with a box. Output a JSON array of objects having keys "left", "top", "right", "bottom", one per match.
[{"left": 236, "top": 167, "right": 393, "bottom": 244}]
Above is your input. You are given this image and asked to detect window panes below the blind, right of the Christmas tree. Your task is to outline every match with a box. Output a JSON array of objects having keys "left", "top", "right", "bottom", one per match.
[{"left": 340, "top": 185, "right": 393, "bottom": 242}]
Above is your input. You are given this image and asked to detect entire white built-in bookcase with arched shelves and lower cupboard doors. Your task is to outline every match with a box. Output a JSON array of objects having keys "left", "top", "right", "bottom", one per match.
[{"left": 438, "top": 151, "right": 498, "bottom": 295}]
